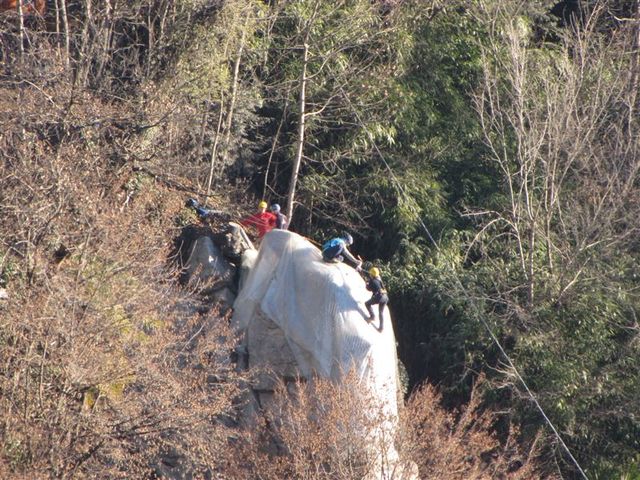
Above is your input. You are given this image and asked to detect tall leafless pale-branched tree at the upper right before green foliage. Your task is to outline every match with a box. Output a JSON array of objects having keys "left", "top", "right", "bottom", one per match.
[{"left": 471, "top": 2, "right": 640, "bottom": 305}]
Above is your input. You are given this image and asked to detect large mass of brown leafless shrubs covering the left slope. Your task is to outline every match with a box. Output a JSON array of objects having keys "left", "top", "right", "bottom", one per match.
[{"left": 0, "top": 69, "right": 248, "bottom": 478}]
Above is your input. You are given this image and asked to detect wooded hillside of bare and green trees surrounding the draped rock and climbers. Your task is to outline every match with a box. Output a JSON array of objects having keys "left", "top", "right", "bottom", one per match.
[{"left": 0, "top": 0, "right": 640, "bottom": 479}]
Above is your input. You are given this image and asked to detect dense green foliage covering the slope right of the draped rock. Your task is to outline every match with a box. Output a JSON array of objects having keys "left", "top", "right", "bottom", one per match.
[{"left": 350, "top": 3, "right": 640, "bottom": 475}]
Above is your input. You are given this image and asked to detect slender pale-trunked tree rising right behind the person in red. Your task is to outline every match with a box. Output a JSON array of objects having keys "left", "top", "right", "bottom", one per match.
[{"left": 267, "top": 0, "right": 408, "bottom": 221}]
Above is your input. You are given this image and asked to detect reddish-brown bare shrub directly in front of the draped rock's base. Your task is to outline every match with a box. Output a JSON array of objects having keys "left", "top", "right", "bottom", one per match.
[{"left": 222, "top": 376, "right": 392, "bottom": 479}]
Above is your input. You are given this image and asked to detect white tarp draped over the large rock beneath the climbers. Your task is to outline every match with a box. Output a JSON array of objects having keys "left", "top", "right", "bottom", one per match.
[{"left": 233, "top": 230, "right": 397, "bottom": 398}]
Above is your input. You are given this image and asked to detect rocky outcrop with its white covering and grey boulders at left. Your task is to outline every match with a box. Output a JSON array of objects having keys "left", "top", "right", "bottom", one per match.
[{"left": 181, "top": 227, "right": 417, "bottom": 480}]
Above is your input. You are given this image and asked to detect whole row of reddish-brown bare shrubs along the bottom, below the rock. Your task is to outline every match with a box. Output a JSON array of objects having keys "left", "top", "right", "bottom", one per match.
[{"left": 224, "top": 376, "right": 543, "bottom": 480}]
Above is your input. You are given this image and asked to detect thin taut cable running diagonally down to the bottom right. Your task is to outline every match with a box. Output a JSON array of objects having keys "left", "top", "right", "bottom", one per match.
[{"left": 341, "top": 89, "right": 589, "bottom": 480}]
